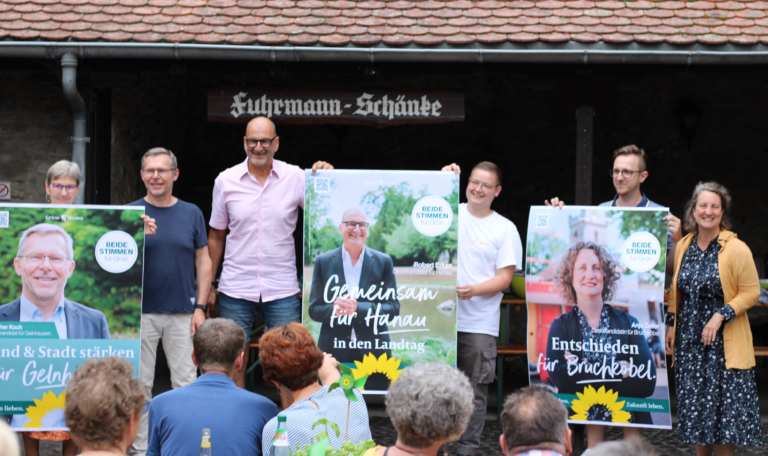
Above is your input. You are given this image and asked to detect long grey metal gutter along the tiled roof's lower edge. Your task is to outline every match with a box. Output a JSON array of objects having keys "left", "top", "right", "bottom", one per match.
[{"left": 0, "top": 41, "right": 768, "bottom": 65}]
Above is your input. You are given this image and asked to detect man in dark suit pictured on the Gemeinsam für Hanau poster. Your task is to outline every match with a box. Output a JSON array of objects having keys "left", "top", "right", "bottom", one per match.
[{"left": 309, "top": 207, "right": 400, "bottom": 390}]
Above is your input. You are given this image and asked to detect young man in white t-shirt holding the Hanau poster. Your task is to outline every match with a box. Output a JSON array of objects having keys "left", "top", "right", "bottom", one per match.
[{"left": 443, "top": 162, "right": 523, "bottom": 455}]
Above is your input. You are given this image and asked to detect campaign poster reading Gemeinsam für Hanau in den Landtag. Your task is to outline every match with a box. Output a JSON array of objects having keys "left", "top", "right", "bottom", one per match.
[{"left": 303, "top": 170, "right": 459, "bottom": 394}]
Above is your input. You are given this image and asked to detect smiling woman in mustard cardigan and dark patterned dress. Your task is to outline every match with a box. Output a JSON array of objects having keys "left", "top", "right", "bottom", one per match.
[{"left": 666, "top": 182, "right": 763, "bottom": 456}]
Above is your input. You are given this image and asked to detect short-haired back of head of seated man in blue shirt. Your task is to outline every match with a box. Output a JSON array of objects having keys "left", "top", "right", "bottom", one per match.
[{"left": 192, "top": 318, "right": 245, "bottom": 372}]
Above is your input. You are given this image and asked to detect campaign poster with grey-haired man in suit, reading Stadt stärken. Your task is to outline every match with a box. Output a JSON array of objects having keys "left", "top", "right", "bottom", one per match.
[{"left": 0, "top": 204, "right": 144, "bottom": 431}]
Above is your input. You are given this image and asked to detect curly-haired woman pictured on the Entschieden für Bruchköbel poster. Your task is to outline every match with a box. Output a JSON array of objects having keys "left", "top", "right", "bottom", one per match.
[{"left": 547, "top": 241, "right": 656, "bottom": 438}]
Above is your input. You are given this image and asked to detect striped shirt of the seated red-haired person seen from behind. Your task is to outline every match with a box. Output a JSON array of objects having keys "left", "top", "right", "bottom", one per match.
[{"left": 261, "top": 386, "right": 371, "bottom": 455}]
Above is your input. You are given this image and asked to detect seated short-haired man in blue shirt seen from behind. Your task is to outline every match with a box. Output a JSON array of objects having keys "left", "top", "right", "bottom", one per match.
[{"left": 147, "top": 318, "right": 277, "bottom": 456}]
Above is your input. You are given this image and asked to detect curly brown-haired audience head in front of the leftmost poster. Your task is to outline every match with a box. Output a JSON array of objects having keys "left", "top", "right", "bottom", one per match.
[{"left": 64, "top": 357, "right": 146, "bottom": 456}]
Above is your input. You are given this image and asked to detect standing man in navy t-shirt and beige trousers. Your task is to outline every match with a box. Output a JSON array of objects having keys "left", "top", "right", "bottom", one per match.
[{"left": 129, "top": 147, "right": 211, "bottom": 456}]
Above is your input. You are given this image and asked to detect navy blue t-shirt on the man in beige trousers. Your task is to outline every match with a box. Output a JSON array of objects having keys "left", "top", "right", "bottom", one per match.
[{"left": 130, "top": 198, "right": 208, "bottom": 313}]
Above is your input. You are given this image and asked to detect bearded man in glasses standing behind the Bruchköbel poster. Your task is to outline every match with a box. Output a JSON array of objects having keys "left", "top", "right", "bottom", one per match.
[{"left": 544, "top": 144, "right": 683, "bottom": 271}]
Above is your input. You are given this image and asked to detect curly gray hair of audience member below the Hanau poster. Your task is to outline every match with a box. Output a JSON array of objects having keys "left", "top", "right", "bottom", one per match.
[{"left": 386, "top": 364, "right": 474, "bottom": 448}]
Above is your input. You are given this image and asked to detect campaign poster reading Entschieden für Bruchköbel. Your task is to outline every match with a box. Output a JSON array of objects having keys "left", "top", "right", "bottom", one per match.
[{"left": 525, "top": 206, "right": 672, "bottom": 429}]
